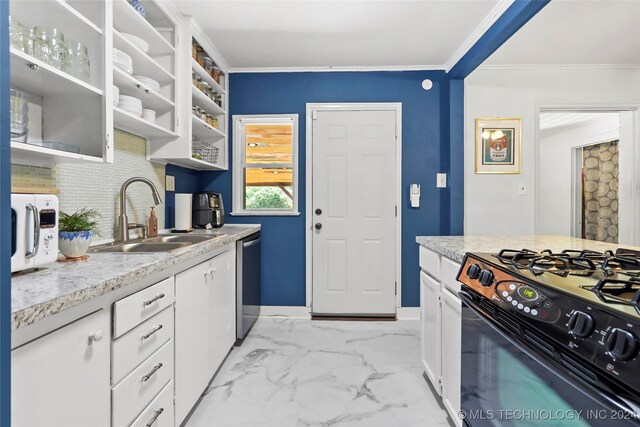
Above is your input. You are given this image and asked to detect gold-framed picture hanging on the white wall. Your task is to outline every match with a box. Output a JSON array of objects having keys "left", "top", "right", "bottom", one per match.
[{"left": 476, "top": 118, "right": 521, "bottom": 174}]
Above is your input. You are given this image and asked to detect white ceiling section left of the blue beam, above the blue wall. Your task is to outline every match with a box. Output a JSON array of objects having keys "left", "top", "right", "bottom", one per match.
[{"left": 177, "top": 0, "right": 510, "bottom": 69}]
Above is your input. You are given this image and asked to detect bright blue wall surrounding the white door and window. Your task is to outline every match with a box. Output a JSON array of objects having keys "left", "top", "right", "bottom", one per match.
[{"left": 199, "top": 71, "right": 462, "bottom": 307}]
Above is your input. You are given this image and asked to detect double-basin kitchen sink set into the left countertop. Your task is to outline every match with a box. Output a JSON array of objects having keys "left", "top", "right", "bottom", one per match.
[{"left": 89, "top": 233, "right": 227, "bottom": 253}]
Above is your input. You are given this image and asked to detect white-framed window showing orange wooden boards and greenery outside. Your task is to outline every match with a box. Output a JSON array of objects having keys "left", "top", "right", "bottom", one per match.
[{"left": 231, "top": 114, "right": 299, "bottom": 215}]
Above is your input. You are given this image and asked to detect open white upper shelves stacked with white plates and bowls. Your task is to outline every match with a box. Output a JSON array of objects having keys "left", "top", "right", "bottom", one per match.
[{"left": 108, "top": 0, "right": 180, "bottom": 145}]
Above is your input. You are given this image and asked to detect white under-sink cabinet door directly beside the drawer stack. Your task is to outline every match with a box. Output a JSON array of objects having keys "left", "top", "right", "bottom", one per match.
[{"left": 175, "top": 261, "right": 212, "bottom": 425}]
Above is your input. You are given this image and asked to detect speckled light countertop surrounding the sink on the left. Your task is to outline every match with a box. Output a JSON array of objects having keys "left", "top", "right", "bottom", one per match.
[{"left": 11, "top": 225, "right": 260, "bottom": 330}]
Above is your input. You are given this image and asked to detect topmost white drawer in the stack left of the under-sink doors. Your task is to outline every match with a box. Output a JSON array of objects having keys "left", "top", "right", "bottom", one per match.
[{"left": 113, "top": 276, "right": 174, "bottom": 339}]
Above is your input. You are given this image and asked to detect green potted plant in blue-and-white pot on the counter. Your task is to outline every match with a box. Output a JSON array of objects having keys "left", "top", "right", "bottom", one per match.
[{"left": 58, "top": 208, "right": 100, "bottom": 258}]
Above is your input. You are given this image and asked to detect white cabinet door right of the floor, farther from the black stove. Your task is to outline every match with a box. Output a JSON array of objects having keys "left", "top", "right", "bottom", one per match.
[{"left": 420, "top": 271, "right": 441, "bottom": 394}]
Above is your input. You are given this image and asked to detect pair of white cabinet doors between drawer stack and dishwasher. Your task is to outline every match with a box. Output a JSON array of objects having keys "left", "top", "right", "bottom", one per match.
[{"left": 175, "top": 245, "right": 235, "bottom": 425}]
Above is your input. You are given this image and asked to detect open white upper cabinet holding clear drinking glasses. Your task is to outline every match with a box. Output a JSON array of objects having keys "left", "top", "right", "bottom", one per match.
[{"left": 10, "top": 0, "right": 113, "bottom": 166}]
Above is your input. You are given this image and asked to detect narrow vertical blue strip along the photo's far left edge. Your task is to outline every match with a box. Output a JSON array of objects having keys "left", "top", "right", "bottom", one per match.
[{"left": 0, "top": 0, "right": 11, "bottom": 426}]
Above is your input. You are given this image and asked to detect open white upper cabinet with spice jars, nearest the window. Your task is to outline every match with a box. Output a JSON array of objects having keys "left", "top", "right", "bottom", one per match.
[{"left": 151, "top": 19, "right": 228, "bottom": 170}]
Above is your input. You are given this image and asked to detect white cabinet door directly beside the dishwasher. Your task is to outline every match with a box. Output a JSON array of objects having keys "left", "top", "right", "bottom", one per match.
[{"left": 209, "top": 247, "right": 236, "bottom": 374}]
